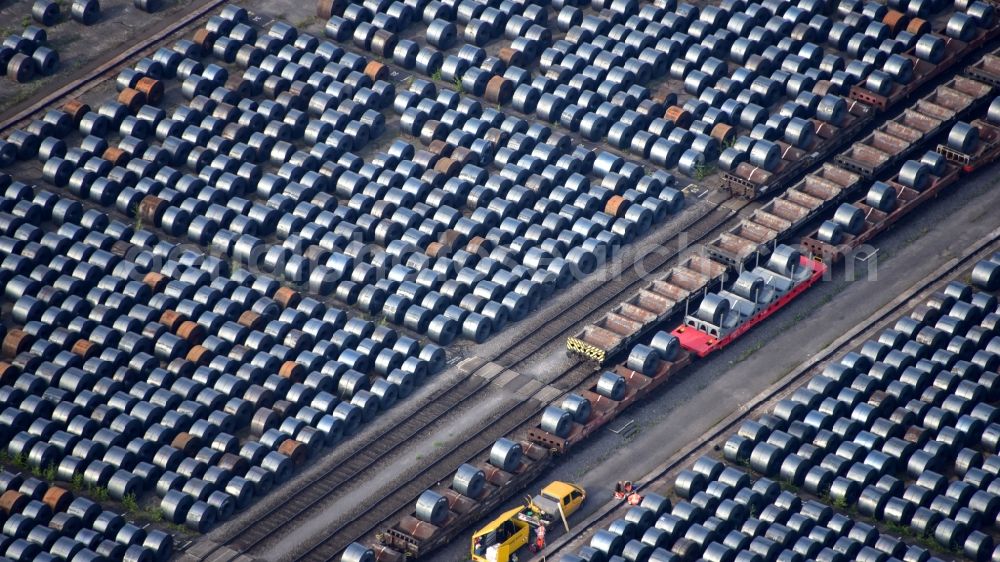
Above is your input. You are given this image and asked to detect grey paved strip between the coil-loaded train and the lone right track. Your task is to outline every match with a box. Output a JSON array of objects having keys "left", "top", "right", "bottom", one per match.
[{"left": 434, "top": 161, "right": 1000, "bottom": 560}]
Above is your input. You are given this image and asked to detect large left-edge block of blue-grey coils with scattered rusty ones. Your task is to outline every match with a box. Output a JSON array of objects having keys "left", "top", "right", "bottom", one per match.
[{"left": 0, "top": 180, "right": 443, "bottom": 531}]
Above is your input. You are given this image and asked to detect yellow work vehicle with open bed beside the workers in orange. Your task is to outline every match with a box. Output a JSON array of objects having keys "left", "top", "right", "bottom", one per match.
[{"left": 471, "top": 481, "right": 587, "bottom": 562}]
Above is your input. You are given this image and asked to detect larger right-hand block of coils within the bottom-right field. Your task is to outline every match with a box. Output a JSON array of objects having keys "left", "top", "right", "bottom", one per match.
[{"left": 724, "top": 282, "right": 1000, "bottom": 559}]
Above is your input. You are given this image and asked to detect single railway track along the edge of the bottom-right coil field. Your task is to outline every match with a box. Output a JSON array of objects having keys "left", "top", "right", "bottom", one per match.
[{"left": 544, "top": 229, "right": 1000, "bottom": 562}]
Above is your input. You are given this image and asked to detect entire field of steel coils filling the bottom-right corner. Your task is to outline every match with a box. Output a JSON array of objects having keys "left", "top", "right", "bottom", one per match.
[{"left": 564, "top": 274, "right": 1000, "bottom": 561}]
